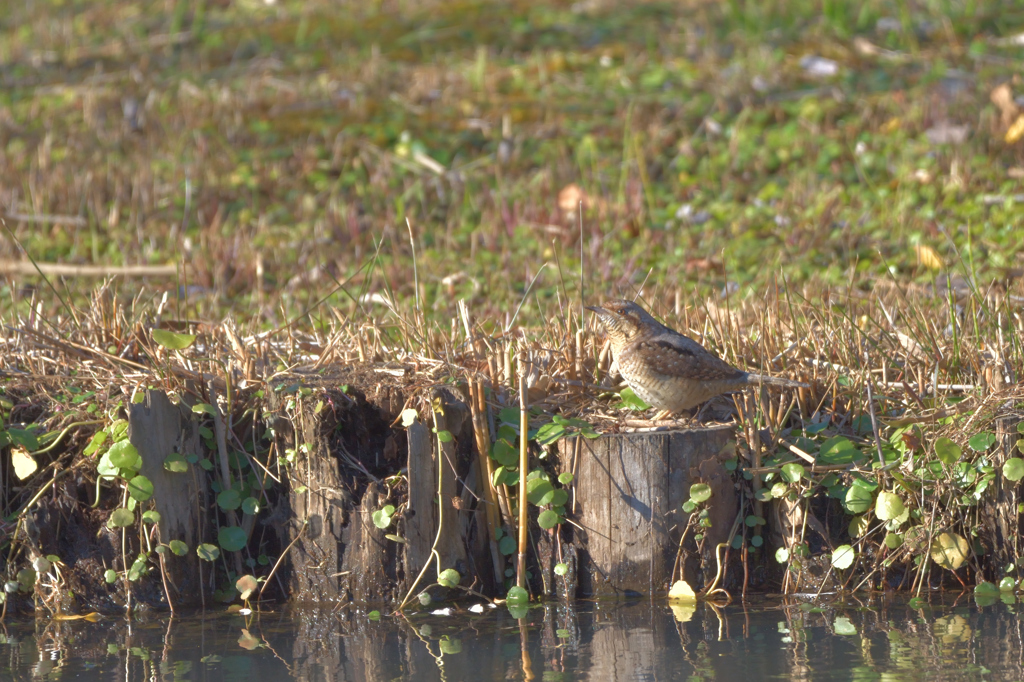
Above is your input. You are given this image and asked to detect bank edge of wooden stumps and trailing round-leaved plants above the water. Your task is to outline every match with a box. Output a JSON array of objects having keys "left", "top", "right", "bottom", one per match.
[{"left": 0, "top": 358, "right": 1020, "bottom": 613}]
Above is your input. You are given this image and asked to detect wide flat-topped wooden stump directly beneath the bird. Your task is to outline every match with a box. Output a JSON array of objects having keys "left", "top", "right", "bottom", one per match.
[{"left": 559, "top": 425, "right": 738, "bottom": 597}]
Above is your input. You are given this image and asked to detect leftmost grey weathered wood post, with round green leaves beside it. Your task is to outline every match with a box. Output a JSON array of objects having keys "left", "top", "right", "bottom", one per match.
[{"left": 128, "top": 390, "right": 210, "bottom": 605}]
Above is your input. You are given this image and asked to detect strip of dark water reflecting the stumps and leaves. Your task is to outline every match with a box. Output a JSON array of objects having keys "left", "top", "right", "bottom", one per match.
[{"left": 0, "top": 595, "right": 1024, "bottom": 682}]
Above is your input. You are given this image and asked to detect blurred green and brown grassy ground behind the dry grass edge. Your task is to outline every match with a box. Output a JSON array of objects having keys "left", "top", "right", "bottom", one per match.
[{"left": 0, "top": 0, "right": 1024, "bottom": 326}]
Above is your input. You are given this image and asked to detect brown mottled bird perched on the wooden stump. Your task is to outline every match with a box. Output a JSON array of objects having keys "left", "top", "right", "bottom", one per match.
[{"left": 587, "top": 300, "right": 807, "bottom": 413}]
